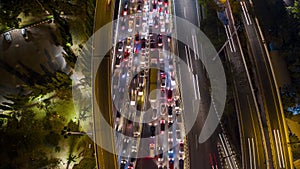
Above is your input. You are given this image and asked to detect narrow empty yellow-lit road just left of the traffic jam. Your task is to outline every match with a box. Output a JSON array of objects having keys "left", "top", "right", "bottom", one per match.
[{"left": 92, "top": 0, "right": 119, "bottom": 169}]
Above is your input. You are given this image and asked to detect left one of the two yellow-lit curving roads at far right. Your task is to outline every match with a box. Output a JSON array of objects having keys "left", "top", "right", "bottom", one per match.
[{"left": 220, "top": 0, "right": 267, "bottom": 169}]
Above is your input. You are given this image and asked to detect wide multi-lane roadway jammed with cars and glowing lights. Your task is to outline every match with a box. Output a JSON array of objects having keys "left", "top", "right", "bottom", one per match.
[{"left": 112, "top": 0, "right": 186, "bottom": 169}]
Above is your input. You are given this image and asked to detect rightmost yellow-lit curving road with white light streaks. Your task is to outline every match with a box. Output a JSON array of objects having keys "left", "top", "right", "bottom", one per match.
[{"left": 241, "top": 2, "right": 292, "bottom": 168}]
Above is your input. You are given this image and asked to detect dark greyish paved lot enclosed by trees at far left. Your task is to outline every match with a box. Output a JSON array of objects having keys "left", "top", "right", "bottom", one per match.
[{"left": 0, "top": 23, "right": 65, "bottom": 90}]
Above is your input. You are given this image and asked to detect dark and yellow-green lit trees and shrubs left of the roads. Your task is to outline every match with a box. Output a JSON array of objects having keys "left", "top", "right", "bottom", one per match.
[{"left": 0, "top": 0, "right": 96, "bottom": 169}]
